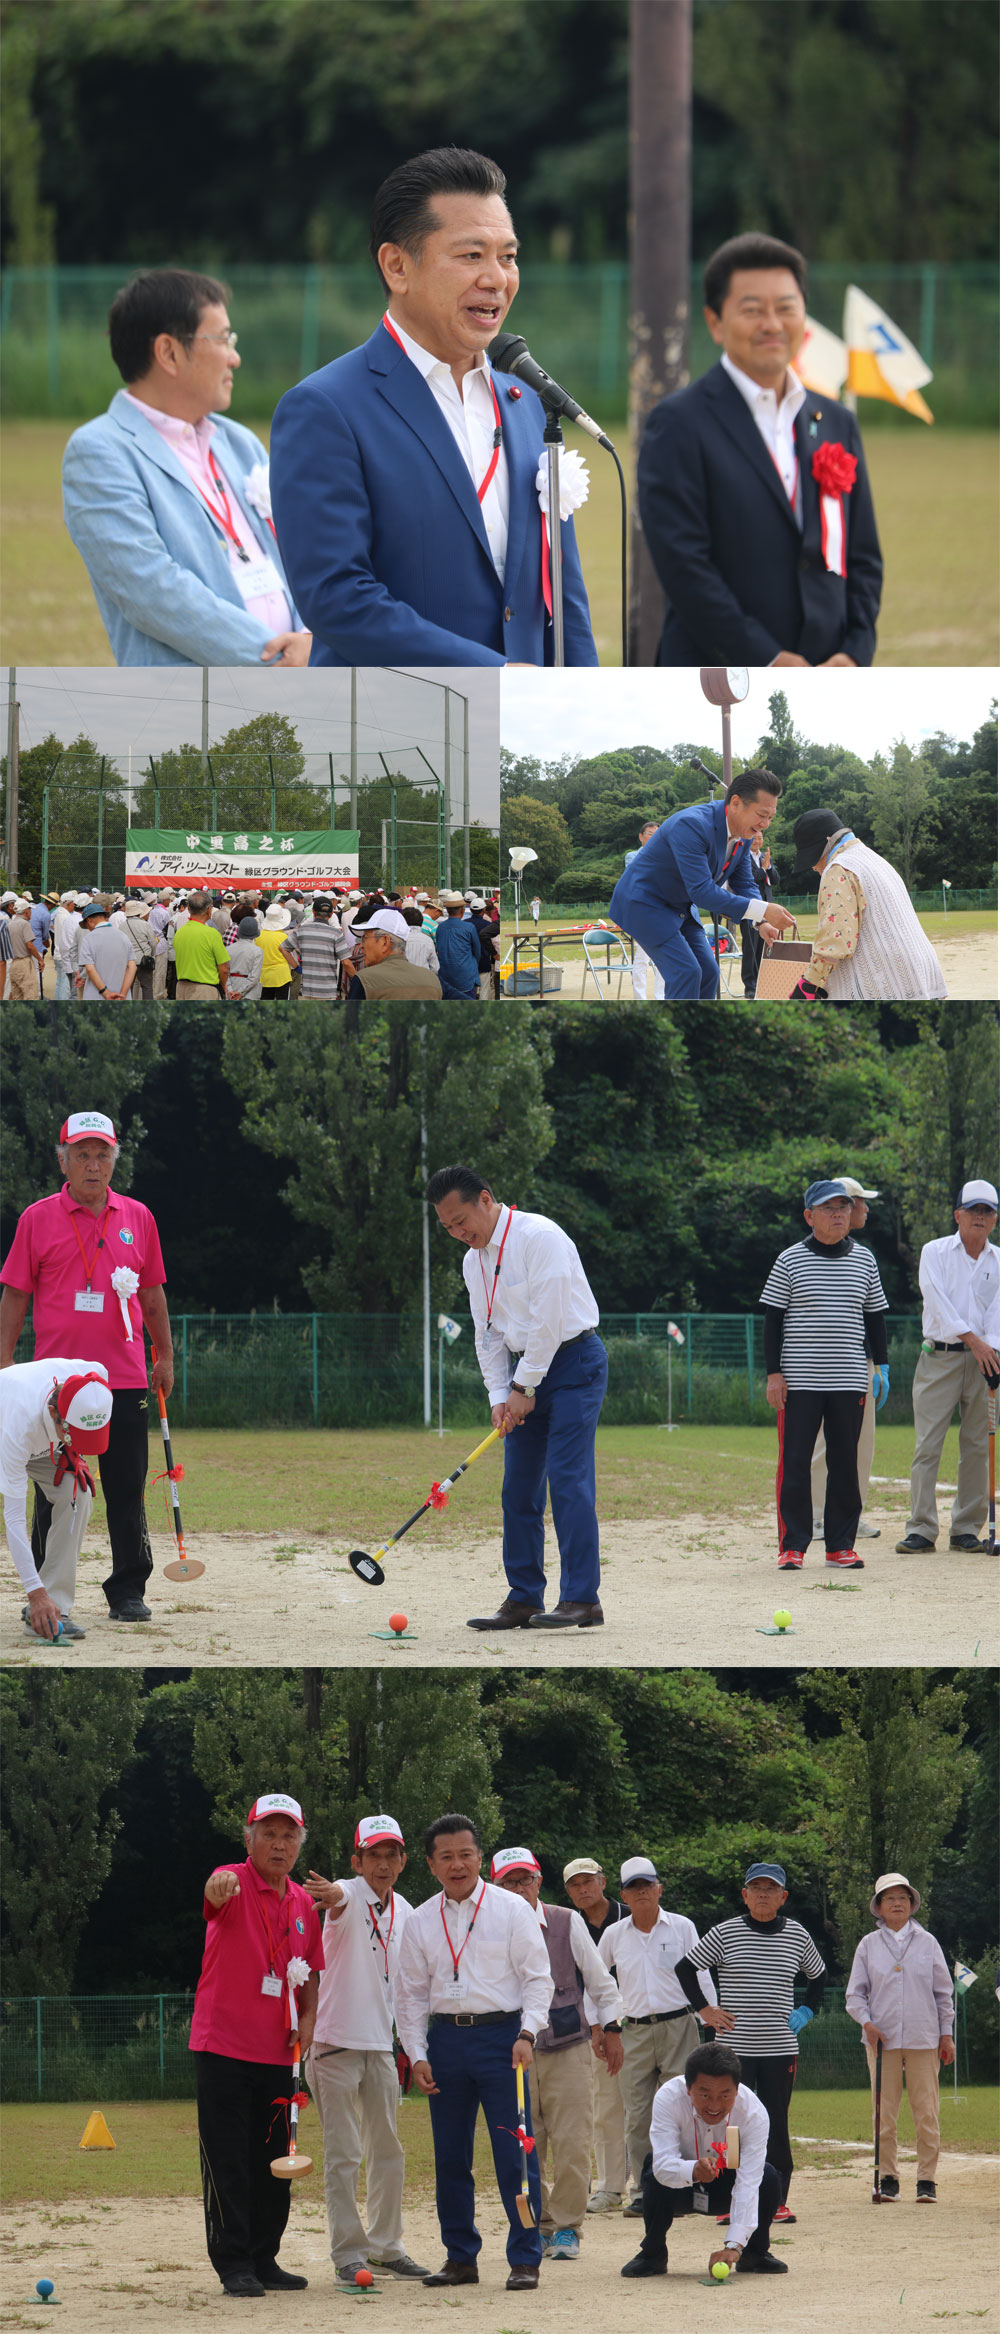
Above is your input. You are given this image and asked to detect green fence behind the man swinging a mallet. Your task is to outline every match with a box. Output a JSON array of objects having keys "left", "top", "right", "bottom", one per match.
[{"left": 16, "top": 1312, "right": 921, "bottom": 1426}]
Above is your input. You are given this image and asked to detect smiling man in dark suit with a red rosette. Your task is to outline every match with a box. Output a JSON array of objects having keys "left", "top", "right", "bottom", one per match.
[{"left": 638, "top": 236, "right": 881, "bottom": 665}]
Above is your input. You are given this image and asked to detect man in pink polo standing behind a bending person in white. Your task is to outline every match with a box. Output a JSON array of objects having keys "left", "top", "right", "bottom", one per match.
[{"left": 0, "top": 1111, "right": 173, "bottom": 1622}]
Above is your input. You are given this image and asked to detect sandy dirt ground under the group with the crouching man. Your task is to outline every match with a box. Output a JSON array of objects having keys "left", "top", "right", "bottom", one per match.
[{"left": 0, "top": 2150, "right": 998, "bottom": 2334}]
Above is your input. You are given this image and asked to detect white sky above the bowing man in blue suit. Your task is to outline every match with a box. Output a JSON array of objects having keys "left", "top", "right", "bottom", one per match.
[{"left": 500, "top": 665, "right": 998, "bottom": 766}]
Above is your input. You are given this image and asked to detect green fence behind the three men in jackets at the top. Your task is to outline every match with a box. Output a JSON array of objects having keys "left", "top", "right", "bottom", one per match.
[{"left": 0, "top": 261, "right": 998, "bottom": 427}]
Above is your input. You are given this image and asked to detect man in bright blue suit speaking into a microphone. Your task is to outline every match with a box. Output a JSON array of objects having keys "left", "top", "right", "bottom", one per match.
[{"left": 271, "top": 147, "right": 598, "bottom": 665}]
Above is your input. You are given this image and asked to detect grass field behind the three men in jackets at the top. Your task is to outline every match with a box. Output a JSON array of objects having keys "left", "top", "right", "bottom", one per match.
[{"left": 0, "top": 415, "right": 998, "bottom": 665}]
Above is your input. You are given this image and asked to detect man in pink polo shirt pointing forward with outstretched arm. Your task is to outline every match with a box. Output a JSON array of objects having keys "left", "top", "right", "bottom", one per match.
[{"left": 189, "top": 1790, "right": 325, "bottom": 2301}]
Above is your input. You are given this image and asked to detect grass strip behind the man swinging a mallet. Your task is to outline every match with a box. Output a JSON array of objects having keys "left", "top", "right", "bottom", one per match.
[{"left": 81, "top": 1403, "right": 958, "bottom": 1550}]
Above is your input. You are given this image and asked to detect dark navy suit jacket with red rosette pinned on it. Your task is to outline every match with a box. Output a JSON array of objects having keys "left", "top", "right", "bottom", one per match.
[{"left": 638, "top": 364, "right": 883, "bottom": 665}]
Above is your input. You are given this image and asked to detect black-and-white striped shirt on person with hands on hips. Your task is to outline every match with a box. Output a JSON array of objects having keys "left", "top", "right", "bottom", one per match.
[{"left": 687, "top": 1914, "right": 827, "bottom": 2059}]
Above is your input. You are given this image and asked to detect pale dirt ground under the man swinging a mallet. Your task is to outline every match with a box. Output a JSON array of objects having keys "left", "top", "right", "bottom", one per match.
[{"left": 0, "top": 1484, "right": 1000, "bottom": 1669}]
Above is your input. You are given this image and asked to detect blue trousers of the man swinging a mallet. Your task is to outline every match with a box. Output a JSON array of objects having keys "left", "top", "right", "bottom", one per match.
[{"left": 502, "top": 1337, "right": 607, "bottom": 1610}]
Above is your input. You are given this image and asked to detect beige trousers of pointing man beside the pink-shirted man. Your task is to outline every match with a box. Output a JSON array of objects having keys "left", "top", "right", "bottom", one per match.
[{"left": 306, "top": 2045, "right": 407, "bottom": 2269}]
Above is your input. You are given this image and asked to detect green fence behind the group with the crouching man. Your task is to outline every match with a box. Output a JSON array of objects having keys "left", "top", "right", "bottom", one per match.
[{"left": 0, "top": 1986, "right": 970, "bottom": 2105}]
